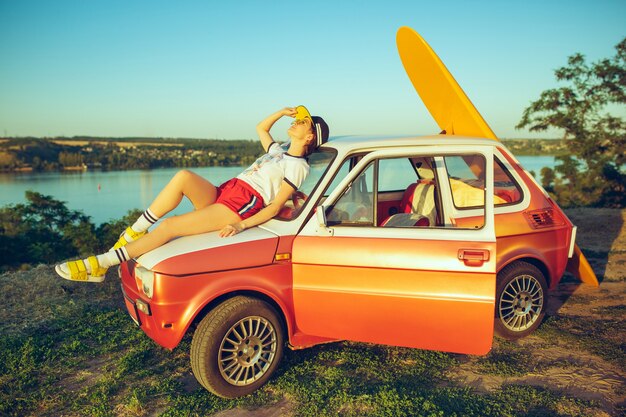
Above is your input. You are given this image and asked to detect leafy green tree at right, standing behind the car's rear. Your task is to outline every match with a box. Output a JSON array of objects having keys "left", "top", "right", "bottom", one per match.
[{"left": 516, "top": 38, "right": 626, "bottom": 207}]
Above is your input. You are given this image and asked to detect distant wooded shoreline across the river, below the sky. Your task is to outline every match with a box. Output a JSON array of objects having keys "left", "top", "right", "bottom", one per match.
[{"left": 0, "top": 136, "right": 569, "bottom": 173}]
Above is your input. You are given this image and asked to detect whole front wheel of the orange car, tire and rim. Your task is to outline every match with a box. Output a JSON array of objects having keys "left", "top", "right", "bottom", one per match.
[{"left": 190, "top": 296, "right": 284, "bottom": 398}]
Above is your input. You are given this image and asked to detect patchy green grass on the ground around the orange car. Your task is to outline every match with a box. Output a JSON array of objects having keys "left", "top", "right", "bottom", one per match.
[{"left": 0, "top": 267, "right": 624, "bottom": 417}]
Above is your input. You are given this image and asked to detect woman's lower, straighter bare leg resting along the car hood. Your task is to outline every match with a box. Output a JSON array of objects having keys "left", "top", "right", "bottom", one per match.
[{"left": 126, "top": 204, "right": 241, "bottom": 258}]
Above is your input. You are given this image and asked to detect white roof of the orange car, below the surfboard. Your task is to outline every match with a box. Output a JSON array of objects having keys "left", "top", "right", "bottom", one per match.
[{"left": 321, "top": 135, "right": 503, "bottom": 153}]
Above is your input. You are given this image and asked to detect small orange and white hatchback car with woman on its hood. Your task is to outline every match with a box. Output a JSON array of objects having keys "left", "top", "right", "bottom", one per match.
[{"left": 120, "top": 29, "right": 597, "bottom": 398}]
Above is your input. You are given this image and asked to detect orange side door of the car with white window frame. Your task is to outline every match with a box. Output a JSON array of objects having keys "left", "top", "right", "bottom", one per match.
[{"left": 292, "top": 146, "right": 496, "bottom": 354}]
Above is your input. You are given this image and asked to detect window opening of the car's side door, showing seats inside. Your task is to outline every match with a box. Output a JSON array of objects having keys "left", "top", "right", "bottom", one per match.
[{"left": 326, "top": 152, "right": 487, "bottom": 229}]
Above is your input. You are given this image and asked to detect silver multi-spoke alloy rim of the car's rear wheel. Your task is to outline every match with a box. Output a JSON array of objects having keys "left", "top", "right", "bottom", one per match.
[{"left": 498, "top": 275, "right": 543, "bottom": 332}]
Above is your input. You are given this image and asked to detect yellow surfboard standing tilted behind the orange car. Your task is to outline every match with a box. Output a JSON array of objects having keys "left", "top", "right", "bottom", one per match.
[{"left": 396, "top": 26, "right": 598, "bottom": 286}]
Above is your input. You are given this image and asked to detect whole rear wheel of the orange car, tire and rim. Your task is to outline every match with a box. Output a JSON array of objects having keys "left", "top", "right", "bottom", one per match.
[{"left": 494, "top": 261, "right": 548, "bottom": 340}]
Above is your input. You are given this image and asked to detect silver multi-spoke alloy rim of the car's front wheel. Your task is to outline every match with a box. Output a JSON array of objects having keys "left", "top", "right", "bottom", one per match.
[{"left": 218, "top": 316, "right": 277, "bottom": 386}]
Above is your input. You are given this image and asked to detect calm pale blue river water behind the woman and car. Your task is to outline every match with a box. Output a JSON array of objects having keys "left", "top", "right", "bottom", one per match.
[{"left": 0, "top": 156, "right": 555, "bottom": 224}]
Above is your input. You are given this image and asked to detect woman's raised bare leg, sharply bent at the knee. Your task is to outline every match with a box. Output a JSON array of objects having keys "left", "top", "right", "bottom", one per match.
[{"left": 149, "top": 170, "right": 217, "bottom": 217}]
